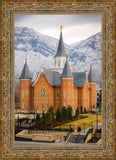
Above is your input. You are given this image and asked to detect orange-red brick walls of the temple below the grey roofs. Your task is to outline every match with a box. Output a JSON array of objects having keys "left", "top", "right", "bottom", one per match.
[{"left": 20, "top": 73, "right": 96, "bottom": 113}]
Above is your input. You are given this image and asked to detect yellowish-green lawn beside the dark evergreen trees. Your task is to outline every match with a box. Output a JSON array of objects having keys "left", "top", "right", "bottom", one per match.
[{"left": 55, "top": 114, "right": 101, "bottom": 130}]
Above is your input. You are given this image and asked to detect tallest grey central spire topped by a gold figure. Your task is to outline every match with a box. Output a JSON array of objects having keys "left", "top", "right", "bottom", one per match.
[{"left": 55, "top": 26, "right": 66, "bottom": 57}]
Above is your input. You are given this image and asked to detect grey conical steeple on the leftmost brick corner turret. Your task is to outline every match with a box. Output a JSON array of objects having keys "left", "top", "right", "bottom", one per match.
[{"left": 19, "top": 58, "right": 32, "bottom": 79}]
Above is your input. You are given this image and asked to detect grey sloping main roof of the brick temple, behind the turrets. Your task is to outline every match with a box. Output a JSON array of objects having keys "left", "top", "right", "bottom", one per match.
[{"left": 31, "top": 69, "right": 86, "bottom": 87}]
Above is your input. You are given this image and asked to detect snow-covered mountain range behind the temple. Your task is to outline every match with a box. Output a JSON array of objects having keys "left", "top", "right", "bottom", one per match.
[{"left": 15, "top": 27, "right": 101, "bottom": 83}]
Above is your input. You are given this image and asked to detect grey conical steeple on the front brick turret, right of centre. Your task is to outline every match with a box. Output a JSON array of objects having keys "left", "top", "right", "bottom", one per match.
[{"left": 61, "top": 56, "right": 73, "bottom": 78}]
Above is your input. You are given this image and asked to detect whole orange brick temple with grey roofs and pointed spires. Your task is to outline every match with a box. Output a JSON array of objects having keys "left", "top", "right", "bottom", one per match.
[{"left": 20, "top": 26, "right": 96, "bottom": 113}]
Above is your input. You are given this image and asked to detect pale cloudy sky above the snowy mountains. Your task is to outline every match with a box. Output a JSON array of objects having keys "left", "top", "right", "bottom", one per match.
[{"left": 15, "top": 15, "right": 101, "bottom": 44}]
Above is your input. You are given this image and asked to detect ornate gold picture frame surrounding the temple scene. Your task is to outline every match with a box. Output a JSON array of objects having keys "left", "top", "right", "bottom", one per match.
[{"left": 0, "top": 1, "right": 115, "bottom": 159}]
